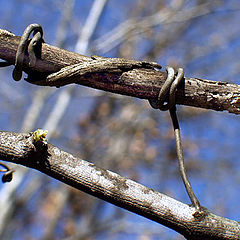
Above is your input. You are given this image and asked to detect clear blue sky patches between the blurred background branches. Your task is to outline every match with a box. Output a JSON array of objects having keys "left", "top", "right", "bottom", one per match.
[{"left": 0, "top": 0, "right": 240, "bottom": 239}]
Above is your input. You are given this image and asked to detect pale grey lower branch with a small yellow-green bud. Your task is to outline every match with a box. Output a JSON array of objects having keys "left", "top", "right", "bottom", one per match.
[{"left": 0, "top": 131, "right": 240, "bottom": 239}]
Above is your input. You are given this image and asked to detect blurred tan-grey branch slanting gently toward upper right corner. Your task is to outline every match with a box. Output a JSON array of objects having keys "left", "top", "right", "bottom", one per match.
[{"left": 92, "top": 1, "right": 219, "bottom": 54}]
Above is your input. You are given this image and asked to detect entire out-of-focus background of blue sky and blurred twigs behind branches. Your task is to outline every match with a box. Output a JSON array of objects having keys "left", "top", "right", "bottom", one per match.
[{"left": 0, "top": 0, "right": 240, "bottom": 240}]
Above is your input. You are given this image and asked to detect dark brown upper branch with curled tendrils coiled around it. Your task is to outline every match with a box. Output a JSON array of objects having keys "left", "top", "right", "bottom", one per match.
[{"left": 0, "top": 29, "right": 240, "bottom": 114}]
